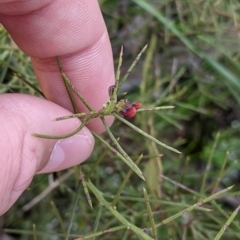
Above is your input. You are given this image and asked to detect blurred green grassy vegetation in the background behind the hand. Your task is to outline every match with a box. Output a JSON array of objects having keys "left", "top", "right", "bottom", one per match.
[{"left": 0, "top": 0, "right": 240, "bottom": 240}]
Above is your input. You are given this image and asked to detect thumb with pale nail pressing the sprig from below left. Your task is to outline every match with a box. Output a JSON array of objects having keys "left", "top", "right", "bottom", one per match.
[{"left": 0, "top": 94, "right": 94, "bottom": 215}]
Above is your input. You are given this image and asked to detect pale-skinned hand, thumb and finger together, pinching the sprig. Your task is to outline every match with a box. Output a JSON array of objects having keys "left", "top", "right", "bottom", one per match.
[{"left": 0, "top": 0, "right": 115, "bottom": 215}]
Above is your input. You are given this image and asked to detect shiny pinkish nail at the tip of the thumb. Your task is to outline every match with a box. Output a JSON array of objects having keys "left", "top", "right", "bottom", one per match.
[{"left": 39, "top": 131, "right": 94, "bottom": 173}]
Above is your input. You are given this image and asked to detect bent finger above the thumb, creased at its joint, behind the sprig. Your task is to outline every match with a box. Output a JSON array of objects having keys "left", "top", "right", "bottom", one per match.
[{"left": 0, "top": 0, "right": 114, "bottom": 132}]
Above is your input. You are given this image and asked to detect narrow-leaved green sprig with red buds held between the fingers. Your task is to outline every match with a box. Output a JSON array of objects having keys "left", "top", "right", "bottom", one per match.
[{"left": 32, "top": 45, "right": 180, "bottom": 180}]
